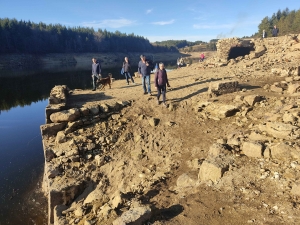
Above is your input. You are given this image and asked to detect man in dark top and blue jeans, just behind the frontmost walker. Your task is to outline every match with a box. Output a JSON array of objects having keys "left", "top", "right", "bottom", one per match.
[{"left": 138, "top": 55, "right": 151, "bottom": 95}]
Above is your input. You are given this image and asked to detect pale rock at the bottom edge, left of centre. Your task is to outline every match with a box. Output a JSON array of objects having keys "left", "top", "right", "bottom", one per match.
[{"left": 113, "top": 206, "right": 151, "bottom": 225}]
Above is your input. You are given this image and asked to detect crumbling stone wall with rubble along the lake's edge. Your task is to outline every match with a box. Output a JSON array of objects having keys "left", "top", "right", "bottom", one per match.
[{"left": 40, "top": 85, "right": 130, "bottom": 224}]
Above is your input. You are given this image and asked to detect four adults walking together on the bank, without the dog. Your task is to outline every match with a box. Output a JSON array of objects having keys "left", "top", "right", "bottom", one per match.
[{"left": 92, "top": 55, "right": 170, "bottom": 107}]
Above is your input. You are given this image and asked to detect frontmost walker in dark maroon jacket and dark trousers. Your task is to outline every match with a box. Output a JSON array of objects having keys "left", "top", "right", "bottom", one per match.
[{"left": 154, "top": 62, "right": 170, "bottom": 107}]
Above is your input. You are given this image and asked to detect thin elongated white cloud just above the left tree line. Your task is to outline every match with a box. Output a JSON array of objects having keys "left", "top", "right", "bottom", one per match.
[{"left": 81, "top": 19, "right": 136, "bottom": 28}]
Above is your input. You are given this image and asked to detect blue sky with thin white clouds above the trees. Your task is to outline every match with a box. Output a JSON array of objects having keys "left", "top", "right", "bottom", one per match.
[{"left": 0, "top": 0, "right": 300, "bottom": 42}]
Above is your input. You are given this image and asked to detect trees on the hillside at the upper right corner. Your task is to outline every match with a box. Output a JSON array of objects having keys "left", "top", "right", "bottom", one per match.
[{"left": 253, "top": 8, "right": 300, "bottom": 37}]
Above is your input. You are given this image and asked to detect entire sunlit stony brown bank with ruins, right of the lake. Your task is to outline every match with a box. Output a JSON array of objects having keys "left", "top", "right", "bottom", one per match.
[{"left": 41, "top": 35, "right": 300, "bottom": 225}]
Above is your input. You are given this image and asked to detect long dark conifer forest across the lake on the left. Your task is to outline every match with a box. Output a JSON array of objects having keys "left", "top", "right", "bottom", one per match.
[{"left": 0, "top": 18, "right": 178, "bottom": 54}]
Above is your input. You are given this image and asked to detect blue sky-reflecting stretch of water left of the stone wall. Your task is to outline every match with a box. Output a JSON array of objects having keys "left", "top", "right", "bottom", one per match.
[{"left": 0, "top": 101, "right": 47, "bottom": 224}]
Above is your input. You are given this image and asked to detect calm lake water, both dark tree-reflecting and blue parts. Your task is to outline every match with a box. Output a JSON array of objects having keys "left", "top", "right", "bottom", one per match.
[{"left": 0, "top": 59, "right": 183, "bottom": 225}]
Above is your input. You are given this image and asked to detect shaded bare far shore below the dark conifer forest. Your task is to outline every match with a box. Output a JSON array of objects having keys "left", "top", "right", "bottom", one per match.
[{"left": 0, "top": 52, "right": 191, "bottom": 73}]
